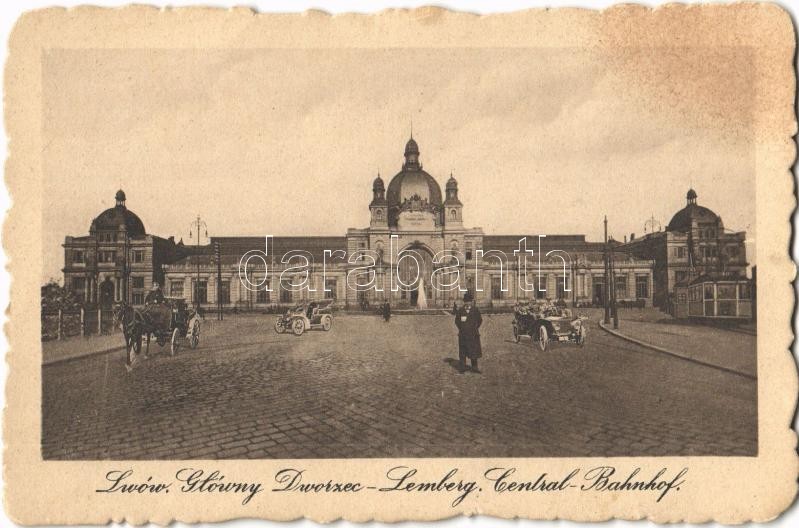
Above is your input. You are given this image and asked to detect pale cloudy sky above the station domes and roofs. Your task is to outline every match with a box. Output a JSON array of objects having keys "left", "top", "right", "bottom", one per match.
[{"left": 42, "top": 48, "right": 755, "bottom": 280}]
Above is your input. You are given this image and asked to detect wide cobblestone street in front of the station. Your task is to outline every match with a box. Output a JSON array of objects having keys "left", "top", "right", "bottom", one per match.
[{"left": 42, "top": 315, "right": 757, "bottom": 459}]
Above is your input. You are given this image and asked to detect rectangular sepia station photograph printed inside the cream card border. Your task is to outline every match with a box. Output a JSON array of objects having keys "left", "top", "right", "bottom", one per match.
[{"left": 41, "top": 48, "right": 758, "bottom": 460}]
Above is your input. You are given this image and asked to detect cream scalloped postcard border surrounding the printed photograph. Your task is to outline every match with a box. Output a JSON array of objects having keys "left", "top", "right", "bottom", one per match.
[{"left": 3, "top": 4, "right": 797, "bottom": 524}]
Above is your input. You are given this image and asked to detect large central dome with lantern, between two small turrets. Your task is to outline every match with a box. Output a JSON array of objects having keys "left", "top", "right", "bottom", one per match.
[{"left": 386, "top": 138, "right": 442, "bottom": 225}]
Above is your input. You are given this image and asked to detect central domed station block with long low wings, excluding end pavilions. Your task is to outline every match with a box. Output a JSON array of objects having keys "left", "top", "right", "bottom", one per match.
[{"left": 164, "top": 138, "right": 654, "bottom": 310}]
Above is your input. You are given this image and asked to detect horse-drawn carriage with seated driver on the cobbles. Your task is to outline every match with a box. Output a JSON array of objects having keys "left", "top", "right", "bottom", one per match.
[{"left": 114, "top": 297, "right": 200, "bottom": 370}]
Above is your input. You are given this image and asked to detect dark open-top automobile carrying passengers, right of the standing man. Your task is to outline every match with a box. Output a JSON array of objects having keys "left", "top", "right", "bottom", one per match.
[{"left": 512, "top": 304, "right": 588, "bottom": 351}]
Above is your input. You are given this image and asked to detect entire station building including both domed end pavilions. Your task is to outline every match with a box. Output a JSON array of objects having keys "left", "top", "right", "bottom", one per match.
[{"left": 69, "top": 138, "right": 764, "bottom": 310}]
